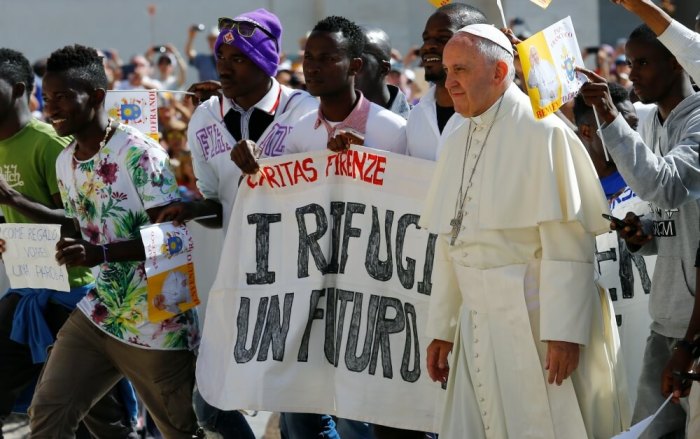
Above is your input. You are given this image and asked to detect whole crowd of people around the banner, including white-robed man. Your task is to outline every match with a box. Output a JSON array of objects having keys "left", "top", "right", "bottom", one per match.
[{"left": 0, "top": 0, "right": 700, "bottom": 439}]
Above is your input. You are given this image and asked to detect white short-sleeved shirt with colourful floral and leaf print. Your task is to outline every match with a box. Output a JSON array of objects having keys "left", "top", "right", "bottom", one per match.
[{"left": 56, "top": 125, "right": 199, "bottom": 349}]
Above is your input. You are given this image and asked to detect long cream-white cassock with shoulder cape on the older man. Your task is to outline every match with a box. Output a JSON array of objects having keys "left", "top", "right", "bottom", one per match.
[{"left": 421, "top": 85, "right": 629, "bottom": 439}]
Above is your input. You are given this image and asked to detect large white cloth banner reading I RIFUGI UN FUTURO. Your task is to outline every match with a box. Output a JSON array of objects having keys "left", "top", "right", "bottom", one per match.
[{"left": 197, "top": 147, "right": 446, "bottom": 431}]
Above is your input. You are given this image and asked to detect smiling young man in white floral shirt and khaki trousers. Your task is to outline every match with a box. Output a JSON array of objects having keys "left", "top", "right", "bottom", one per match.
[{"left": 29, "top": 45, "right": 199, "bottom": 438}]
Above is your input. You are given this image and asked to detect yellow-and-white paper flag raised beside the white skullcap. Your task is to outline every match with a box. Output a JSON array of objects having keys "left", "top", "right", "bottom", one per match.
[{"left": 516, "top": 17, "right": 585, "bottom": 119}]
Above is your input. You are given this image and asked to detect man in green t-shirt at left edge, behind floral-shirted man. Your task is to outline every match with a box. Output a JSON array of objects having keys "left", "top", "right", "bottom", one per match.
[{"left": 0, "top": 48, "right": 138, "bottom": 439}]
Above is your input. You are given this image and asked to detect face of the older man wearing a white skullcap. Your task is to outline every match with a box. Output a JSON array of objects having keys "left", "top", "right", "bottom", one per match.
[{"left": 443, "top": 34, "right": 496, "bottom": 117}]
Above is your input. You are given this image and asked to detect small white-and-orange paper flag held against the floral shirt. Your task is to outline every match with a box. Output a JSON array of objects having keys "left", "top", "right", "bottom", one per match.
[{"left": 141, "top": 222, "right": 199, "bottom": 322}]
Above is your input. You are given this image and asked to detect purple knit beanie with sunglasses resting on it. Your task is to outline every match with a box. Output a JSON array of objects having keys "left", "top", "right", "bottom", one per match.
[{"left": 214, "top": 8, "right": 282, "bottom": 76}]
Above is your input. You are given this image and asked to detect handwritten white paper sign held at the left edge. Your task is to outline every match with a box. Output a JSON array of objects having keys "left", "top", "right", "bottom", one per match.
[{"left": 0, "top": 223, "right": 70, "bottom": 291}]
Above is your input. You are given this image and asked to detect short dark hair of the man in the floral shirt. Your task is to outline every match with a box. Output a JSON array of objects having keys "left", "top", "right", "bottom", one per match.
[{"left": 46, "top": 44, "right": 109, "bottom": 90}]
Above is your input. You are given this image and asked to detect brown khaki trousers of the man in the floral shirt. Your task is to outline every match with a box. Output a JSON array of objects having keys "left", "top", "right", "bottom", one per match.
[{"left": 29, "top": 310, "right": 197, "bottom": 439}]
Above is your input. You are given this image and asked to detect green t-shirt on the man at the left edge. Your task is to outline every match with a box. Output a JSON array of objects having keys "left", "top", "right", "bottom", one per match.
[{"left": 0, "top": 119, "right": 94, "bottom": 287}]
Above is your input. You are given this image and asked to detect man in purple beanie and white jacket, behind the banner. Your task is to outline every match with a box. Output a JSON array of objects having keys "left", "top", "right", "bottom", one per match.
[{"left": 159, "top": 9, "right": 318, "bottom": 439}]
